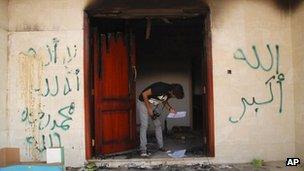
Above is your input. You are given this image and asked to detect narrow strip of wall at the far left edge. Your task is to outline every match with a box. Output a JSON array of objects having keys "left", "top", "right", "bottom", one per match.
[{"left": 0, "top": 0, "right": 9, "bottom": 148}]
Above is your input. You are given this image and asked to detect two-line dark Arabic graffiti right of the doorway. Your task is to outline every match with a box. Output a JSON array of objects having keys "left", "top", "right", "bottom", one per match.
[{"left": 229, "top": 45, "right": 285, "bottom": 123}]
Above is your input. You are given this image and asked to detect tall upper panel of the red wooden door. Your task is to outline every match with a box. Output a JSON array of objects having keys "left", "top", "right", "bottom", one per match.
[{"left": 100, "top": 36, "right": 129, "bottom": 99}]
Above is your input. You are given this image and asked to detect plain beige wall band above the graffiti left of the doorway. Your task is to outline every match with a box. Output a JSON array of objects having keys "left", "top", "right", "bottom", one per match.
[{"left": 9, "top": 0, "right": 89, "bottom": 32}]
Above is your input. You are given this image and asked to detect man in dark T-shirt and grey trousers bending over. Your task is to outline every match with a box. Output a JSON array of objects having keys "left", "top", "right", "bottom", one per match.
[{"left": 136, "top": 82, "right": 184, "bottom": 157}]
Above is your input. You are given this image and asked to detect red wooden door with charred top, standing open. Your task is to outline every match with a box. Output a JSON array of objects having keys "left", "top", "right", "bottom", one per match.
[{"left": 93, "top": 29, "right": 136, "bottom": 155}]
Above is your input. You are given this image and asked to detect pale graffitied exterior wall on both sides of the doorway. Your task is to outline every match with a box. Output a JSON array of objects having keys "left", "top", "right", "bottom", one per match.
[{"left": 8, "top": 0, "right": 299, "bottom": 166}]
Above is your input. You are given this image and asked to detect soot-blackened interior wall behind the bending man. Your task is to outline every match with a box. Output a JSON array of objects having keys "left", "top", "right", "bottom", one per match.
[{"left": 134, "top": 18, "right": 202, "bottom": 130}]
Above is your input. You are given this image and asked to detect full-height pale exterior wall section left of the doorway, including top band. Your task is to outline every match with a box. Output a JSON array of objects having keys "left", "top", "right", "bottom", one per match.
[{"left": 8, "top": 0, "right": 86, "bottom": 166}]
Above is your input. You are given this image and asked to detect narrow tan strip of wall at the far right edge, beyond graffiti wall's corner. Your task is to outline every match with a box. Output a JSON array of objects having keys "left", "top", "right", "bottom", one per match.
[{"left": 291, "top": 3, "right": 304, "bottom": 160}]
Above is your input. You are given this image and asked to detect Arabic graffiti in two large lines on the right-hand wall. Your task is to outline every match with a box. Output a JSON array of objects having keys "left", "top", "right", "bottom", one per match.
[{"left": 229, "top": 45, "right": 285, "bottom": 123}]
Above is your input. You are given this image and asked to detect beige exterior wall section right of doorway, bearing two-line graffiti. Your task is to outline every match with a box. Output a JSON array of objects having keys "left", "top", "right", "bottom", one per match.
[{"left": 210, "top": 0, "right": 295, "bottom": 162}]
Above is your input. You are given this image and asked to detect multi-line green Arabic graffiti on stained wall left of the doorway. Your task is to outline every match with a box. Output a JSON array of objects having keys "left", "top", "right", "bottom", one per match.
[{"left": 19, "top": 38, "right": 80, "bottom": 159}]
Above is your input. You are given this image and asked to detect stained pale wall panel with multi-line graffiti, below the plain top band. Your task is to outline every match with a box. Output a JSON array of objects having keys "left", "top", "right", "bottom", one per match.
[{"left": 8, "top": 30, "right": 84, "bottom": 165}]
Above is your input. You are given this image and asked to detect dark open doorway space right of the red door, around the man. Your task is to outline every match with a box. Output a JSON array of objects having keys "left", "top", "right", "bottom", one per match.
[{"left": 133, "top": 16, "right": 207, "bottom": 157}]
